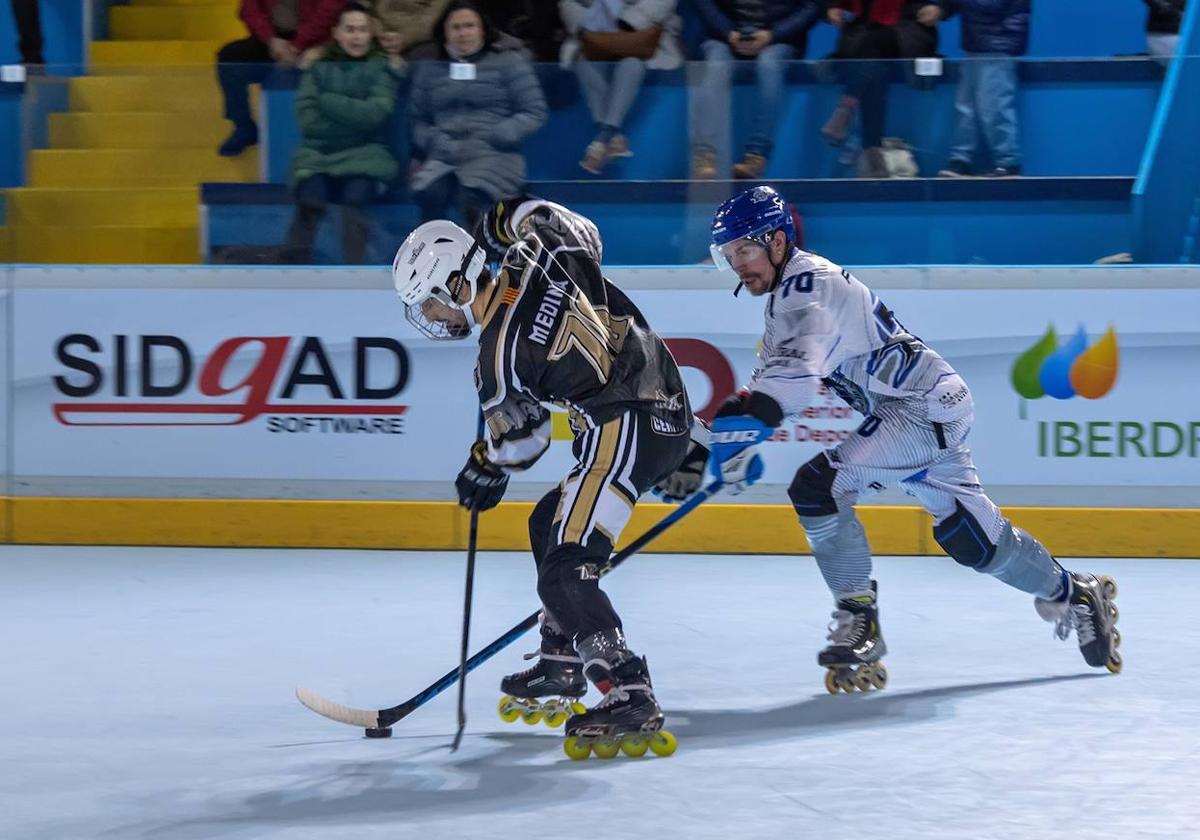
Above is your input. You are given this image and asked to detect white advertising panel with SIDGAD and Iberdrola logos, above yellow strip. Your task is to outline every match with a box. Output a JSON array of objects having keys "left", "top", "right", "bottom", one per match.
[{"left": 12, "top": 269, "right": 1200, "bottom": 486}]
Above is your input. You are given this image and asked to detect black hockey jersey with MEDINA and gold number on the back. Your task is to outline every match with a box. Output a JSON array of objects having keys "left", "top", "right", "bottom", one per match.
[{"left": 475, "top": 199, "right": 691, "bottom": 472}]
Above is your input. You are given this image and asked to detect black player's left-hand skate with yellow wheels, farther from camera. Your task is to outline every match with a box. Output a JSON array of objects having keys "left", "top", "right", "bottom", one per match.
[{"left": 497, "top": 622, "right": 588, "bottom": 728}]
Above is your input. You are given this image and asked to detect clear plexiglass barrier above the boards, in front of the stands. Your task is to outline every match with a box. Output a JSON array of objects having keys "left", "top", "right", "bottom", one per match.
[{"left": 0, "top": 54, "right": 1200, "bottom": 265}]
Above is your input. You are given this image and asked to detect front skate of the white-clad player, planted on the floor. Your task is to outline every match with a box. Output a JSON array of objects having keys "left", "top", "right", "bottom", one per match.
[{"left": 817, "top": 581, "right": 888, "bottom": 694}]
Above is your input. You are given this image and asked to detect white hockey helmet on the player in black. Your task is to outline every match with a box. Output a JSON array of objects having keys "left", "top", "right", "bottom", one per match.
[{"left": 391, "top": 220, "right": 486, "bottom": 338}]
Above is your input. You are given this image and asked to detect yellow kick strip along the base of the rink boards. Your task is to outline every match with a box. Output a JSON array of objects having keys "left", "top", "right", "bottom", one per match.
[{"left": 7, "top": 497, "right": 1200, "bottom": 557}]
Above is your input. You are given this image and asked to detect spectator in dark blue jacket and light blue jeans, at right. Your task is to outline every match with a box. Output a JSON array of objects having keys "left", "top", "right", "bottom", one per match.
[{"left": 937, "top": 0, "right": 1031, "bottom": 178}]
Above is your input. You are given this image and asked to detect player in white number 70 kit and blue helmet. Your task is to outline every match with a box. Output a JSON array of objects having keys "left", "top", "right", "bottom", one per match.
[{"left": 662, "top": 186, "right": 1121, "bottom": 694}]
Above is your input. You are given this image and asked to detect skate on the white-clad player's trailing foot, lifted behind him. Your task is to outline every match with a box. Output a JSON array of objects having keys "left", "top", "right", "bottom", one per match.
[{"left": 1033, "top": 571, "right": 1121, "bottom": 673}]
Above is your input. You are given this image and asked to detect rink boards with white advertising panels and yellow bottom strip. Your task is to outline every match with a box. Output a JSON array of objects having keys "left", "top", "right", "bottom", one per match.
[{"left": 0, "top": 266, "right": 1200, "bottom": 556}]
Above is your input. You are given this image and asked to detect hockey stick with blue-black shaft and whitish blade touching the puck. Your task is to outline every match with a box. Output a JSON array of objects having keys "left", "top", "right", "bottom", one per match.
[{"left": 296, "top": 481, "right": 721, "bottom": 728}]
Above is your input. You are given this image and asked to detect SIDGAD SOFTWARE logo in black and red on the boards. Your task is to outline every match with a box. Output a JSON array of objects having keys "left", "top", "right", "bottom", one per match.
[{"left": 52, "top": 332, "right": 409, "bottom": 434}]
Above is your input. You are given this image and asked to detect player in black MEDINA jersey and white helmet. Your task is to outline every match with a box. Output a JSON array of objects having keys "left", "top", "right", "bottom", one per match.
[{"left": 392, "top": 198, "right": 703, "bottom": 758}]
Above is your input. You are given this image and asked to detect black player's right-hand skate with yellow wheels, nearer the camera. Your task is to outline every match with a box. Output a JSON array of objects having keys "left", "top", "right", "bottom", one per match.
[{"left": 563, "top": 630, "right": 676, "bottom": 761}]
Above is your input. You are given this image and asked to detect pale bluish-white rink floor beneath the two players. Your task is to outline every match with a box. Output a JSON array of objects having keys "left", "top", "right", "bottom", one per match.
[{"left": 0, "top": 546, "right": 1200, "bottom": 840}]
